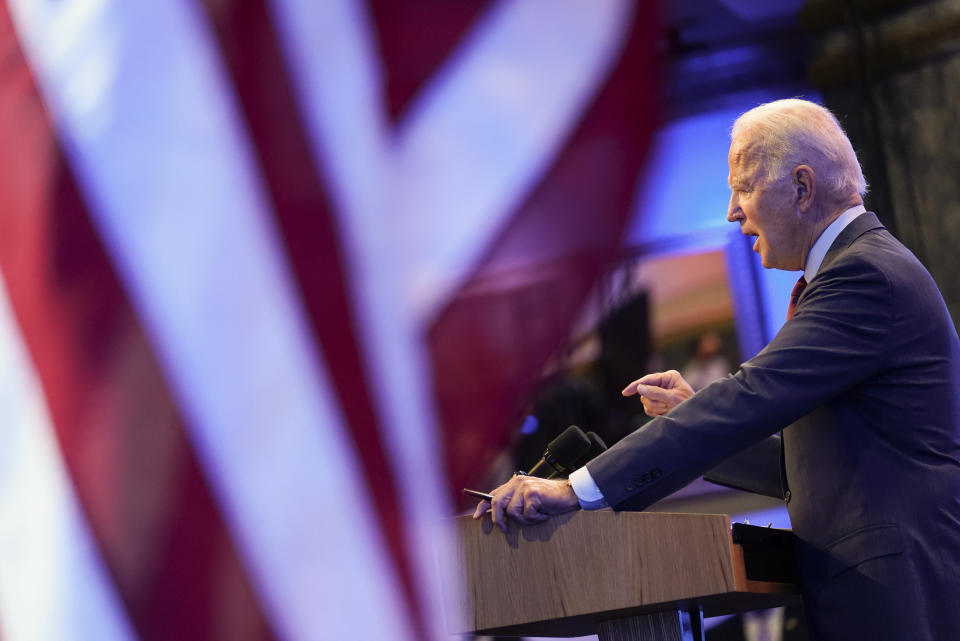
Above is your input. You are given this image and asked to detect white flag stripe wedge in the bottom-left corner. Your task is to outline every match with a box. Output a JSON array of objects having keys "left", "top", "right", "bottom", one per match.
[{"left": 0, "top": 279, "right": 137, "bottom": 641}]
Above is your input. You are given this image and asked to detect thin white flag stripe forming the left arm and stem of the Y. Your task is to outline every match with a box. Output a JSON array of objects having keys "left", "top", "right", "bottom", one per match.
[{"left": 273, "top": 0, "right": 464, "bottom": 638}]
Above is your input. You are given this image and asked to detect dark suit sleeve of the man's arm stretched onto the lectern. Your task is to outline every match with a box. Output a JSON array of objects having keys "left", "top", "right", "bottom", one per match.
[{"left": 587, "top": 257, "right": 892, "bottom": 510}]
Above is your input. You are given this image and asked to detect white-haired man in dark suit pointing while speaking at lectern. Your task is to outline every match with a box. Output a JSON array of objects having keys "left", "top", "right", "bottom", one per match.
[{"left": 475, "top": 100, "right": 960, "bottom": 641}]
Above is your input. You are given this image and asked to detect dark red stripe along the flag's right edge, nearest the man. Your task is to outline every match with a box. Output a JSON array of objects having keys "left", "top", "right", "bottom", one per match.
[{"left": 429, "top": 0, "right": 657, "bottom": 502}]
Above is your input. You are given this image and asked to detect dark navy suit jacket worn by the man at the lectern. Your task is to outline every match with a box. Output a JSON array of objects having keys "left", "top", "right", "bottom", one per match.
[{"left": 587, "top": 213, "right": 960, "bottom": 641}]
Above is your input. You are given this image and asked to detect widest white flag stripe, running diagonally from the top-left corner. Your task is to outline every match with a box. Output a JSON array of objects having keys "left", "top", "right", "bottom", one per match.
[{"left": 11, "top": 0, "right": 408, "bottom": 639}]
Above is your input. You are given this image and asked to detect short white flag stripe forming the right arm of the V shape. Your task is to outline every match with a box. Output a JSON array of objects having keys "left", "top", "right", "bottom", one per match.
[{"left": 390, "top": 0, "right": 632, "bottom": 322}]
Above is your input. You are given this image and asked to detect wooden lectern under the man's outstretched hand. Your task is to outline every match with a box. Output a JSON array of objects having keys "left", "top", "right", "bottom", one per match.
[{"left": 446, "top": 510, "right": 800, "bottom": 641}]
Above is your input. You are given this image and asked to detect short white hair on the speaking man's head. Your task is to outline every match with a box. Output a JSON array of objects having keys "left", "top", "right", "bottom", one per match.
[{"left": 730, "top": 98, "right": 867, "bottom": 201}]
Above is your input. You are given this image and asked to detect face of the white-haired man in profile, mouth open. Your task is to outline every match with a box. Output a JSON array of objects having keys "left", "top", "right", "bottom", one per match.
[{"left": 727, "top": 139, "right": 806, "bottom": 271}]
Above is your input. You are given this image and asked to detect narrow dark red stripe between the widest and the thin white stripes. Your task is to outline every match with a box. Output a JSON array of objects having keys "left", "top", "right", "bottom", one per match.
[{"left": 197, "top": 0, "right": 429, "bottom": 639}]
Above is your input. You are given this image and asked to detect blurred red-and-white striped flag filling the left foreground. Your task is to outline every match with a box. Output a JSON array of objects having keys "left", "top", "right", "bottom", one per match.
[{"left": 0, "top": 0, "right": 656, "bottom": 641}]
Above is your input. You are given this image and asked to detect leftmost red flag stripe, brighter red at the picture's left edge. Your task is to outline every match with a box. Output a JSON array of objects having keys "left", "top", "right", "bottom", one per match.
[{"left": 0, "top": 2, "right": 272, "bottom": 641}]
